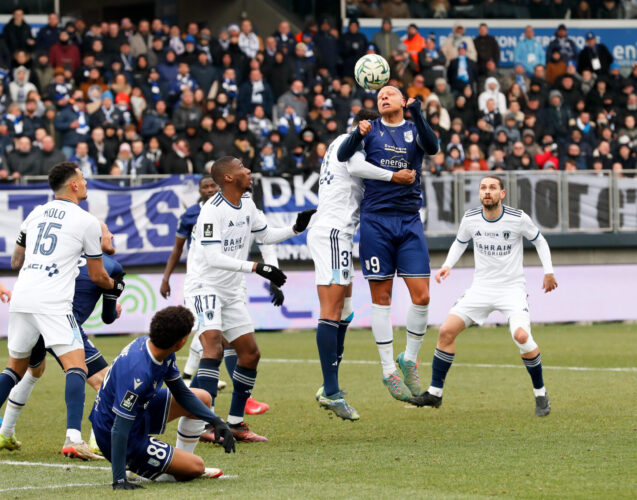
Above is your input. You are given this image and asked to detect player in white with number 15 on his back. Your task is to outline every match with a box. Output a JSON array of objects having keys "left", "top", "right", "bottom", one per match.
[{"left": 0, "top": 162, "right": 124, "bottom": 459}]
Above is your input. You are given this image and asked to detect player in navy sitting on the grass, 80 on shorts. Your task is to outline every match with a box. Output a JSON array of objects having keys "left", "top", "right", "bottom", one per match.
[{"left": 89, "top": 306, "right": 235, "bottom": 490}]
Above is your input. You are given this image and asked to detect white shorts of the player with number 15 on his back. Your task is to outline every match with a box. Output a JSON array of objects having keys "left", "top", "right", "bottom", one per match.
[{"left": 7, "top": 312, "right": 84, "bottom": 359}]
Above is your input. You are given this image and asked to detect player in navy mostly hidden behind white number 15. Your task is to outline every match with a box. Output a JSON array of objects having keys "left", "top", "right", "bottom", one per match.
[{"left": 0, "top": 222, "right": 124, "bottom": 460}]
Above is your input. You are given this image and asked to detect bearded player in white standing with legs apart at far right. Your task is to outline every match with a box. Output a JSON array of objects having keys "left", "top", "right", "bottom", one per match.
[{"left": 412, "top": 176, "right": 557, "bottom": 417}]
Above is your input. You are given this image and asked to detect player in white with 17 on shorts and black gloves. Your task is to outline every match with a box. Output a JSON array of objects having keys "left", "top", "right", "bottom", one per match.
[{"left": 184, "top": 156, "right": 315, "bottom": 441}]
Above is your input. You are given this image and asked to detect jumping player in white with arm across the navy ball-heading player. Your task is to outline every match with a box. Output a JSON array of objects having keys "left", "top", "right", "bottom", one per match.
[{"left": 307, "top": 109, "right": 416, "bottom": 420}]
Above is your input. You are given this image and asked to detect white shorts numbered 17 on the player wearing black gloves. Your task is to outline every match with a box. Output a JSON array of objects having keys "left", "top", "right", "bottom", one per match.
[{"left": 185, "top": 291, "right": 254, "bottom": 342}]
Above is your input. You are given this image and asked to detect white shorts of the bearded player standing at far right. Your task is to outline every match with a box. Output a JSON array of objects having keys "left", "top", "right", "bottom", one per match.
[{"left": 449, "top": 287, "right": 531, "bottom": 334}]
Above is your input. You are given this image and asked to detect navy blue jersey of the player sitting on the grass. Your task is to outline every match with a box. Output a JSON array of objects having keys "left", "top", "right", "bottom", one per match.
[{"left": 89, "top": 336, "right": 180, "bottom": 434}]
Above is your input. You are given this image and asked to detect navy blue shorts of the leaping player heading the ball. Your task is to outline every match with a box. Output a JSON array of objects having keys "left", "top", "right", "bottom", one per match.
[{"left": 359, "top": 212, "right": 431, "bottom": 280}]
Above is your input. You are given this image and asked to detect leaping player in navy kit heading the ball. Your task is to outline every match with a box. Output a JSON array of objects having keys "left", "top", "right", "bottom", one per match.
[{"left": 337, "top": 86, "right": 439, "bottom": 401}]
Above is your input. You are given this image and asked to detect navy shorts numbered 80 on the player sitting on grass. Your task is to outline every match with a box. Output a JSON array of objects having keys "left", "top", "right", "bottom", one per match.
[{"left": 93, "top": 387, "right": 175, "bottom": 479}]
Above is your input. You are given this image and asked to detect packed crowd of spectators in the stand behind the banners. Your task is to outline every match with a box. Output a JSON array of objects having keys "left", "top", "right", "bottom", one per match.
[{"left": 0, "top": 6, "right": 637, "bottom": 182}]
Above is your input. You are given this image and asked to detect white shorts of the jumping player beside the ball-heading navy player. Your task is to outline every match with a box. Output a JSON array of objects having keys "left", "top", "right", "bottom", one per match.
[{"left": 307, "top": 226, "right": 354, "bottom": 286}]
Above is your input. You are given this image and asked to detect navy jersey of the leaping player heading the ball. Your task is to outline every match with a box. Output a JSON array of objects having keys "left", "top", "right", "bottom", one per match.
[{"left": 361, "top": 118, "right": 425, "bottom": 213}]
